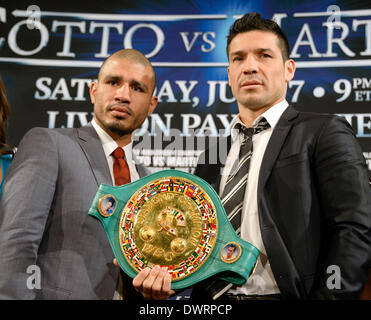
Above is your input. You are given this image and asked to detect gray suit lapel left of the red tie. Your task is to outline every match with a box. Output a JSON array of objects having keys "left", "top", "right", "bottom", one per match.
[{"left": 76, "top": 124, "right": 112, "bottom": 186}]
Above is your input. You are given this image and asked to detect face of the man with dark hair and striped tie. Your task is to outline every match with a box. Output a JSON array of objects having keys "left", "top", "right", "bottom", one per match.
[{"left": 228, "top": 30, "right": 295, "bottom": 111}]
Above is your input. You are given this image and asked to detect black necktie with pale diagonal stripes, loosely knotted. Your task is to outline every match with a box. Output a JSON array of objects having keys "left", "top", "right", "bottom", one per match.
[{"left": 221, "top": 118, "right": 270, "bottom": 235}]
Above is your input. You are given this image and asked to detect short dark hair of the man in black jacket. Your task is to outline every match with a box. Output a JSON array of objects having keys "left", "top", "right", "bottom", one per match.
[{"left": 227, "top": 12, "right": 290, "bottom": 61}]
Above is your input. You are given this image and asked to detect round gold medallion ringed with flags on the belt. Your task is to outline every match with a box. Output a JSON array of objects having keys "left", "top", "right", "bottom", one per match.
[{"left": 119, "top": 177, "right": 218, "bottom": 281}]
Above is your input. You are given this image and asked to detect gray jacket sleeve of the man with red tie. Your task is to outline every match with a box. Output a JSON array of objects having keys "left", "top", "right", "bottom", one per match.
[{"left": 0, "top": 128, "right": 58, "bottom": 299}]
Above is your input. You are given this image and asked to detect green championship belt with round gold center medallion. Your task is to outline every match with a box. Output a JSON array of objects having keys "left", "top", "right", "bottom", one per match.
[{"left": 89, "top": 170, "right": 259, "bottom": 289}]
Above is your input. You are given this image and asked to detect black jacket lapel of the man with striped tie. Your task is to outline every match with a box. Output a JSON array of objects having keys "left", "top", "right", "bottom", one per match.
[{"left": 258, "top": 106, "right": 299, "bottom": 195}]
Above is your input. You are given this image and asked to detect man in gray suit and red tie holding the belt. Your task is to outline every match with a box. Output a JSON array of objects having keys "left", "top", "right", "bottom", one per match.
[{"left": 0, "top": 50, "right": 170, "bottom": 299}]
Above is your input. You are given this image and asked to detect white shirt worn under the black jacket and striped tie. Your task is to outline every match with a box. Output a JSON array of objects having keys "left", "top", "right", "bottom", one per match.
[{"left": 219, "top": 100, "right": 288, "bottom": 295}]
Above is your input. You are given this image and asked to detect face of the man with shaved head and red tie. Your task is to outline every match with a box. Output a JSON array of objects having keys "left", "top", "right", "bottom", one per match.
[{"left": 90, "top": 57, "right": 157, "bottom": 137}]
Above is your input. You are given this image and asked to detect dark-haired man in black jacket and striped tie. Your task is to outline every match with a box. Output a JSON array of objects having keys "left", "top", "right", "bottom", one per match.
[{"left": 193, "top": 13, "right": 371, "bottom": 300}]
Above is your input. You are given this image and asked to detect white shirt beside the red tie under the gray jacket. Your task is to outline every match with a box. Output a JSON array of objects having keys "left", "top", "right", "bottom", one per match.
[{"left": 91, "top": 119, "right": 139, "bottom": 185}]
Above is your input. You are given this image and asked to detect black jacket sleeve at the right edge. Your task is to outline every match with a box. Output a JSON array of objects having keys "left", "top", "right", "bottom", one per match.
[{"left": 311, "top": 117, "right": 371, "bottom": 299}]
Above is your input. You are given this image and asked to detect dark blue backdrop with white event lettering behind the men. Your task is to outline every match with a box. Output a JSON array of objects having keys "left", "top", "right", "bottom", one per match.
[{"left": 0, "top": 0, "right": 371, "bottom": 172}]
